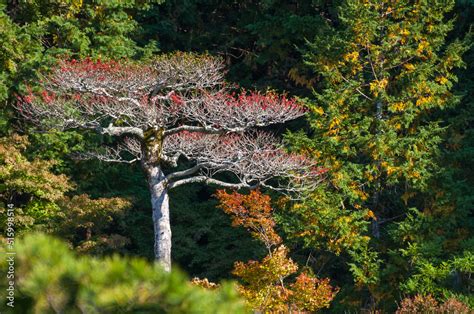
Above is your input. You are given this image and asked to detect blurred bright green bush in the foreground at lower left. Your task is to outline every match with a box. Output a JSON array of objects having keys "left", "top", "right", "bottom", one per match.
[{"left": 0, "top": 233, "right": 246, "bottom": 313}]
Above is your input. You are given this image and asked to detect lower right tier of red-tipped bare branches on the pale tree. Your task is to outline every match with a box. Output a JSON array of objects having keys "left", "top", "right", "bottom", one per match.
[{"left": 163, "top": 132, "right": 324, "bottom": 192}]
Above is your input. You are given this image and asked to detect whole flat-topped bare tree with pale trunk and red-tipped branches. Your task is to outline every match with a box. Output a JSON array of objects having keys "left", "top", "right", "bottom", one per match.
[{"left": 17, "top": 53, "right": 321, "bottom": 270}]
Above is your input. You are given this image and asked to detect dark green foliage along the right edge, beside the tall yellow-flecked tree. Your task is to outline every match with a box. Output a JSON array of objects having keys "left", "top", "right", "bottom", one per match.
[{"left": 393, "top": 4, "right": 474, "bottom": 307}]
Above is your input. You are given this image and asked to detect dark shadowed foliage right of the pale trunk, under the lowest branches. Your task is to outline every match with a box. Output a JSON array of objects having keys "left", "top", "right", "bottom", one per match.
[{"left": 170, "top": 184, "right": 265, "bottom": 281}]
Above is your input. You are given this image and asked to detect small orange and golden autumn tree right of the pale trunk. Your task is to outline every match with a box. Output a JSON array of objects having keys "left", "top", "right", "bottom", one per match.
[{"left": 216, "top": 190, "right": 337, "bottom": 313}]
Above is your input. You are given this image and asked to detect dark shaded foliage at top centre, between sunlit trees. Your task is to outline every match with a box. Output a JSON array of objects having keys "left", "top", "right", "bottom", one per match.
[{"left": 139, "top": 0, "right": 339, "bottom": 92}]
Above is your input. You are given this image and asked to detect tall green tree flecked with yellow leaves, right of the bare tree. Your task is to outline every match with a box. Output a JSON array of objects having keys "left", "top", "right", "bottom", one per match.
[{"left": 290, "top": 0, "right": 466, "bottom": 305}]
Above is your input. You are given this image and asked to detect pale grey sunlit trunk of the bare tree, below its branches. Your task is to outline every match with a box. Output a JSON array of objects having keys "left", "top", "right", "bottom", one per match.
[{"left": 147, "top": 167, "right": 171, "bottom": 271}]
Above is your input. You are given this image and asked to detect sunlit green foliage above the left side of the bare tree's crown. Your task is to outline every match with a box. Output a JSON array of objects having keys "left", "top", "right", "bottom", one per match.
[{"left": 7, "top": 0, "right": 161, "bottom": 58}]
